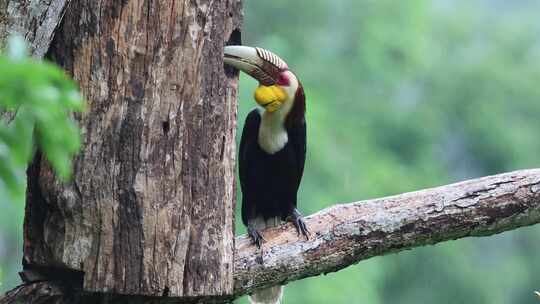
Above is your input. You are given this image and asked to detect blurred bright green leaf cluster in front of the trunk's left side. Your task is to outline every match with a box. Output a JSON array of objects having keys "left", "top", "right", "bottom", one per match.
[{"left": 0, "top": 36, "right": 84, "bottom": 200}]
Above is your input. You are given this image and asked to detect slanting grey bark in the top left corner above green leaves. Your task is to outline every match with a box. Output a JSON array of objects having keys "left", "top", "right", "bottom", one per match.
[{"left": 0, "top": 0, "right": 70, "bottom": 58}]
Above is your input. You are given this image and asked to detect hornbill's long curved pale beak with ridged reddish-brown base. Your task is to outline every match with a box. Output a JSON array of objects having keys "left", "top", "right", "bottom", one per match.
[{"left": 223, "top": 45, "right": 289, "bottom": 86}]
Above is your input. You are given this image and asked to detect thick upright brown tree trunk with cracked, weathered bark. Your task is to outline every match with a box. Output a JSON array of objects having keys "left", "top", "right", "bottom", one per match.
[{"left": 23, "top": 0, "right": 241, "bottom": 297}]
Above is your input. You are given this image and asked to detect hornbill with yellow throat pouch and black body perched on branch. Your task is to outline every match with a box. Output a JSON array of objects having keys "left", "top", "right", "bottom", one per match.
[{"left": 224, "top": 46, "right": 308, "bottom": 303}]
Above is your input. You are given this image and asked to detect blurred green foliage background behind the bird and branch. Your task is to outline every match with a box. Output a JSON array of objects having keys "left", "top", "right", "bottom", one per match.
[{"left": 0, "top": 0, "right": 540, "bottom": 304}]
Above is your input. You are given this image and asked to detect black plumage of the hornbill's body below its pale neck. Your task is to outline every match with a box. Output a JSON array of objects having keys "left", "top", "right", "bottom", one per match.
[{"left": 239, "top": 109, "right": 306, "bottom": 226}]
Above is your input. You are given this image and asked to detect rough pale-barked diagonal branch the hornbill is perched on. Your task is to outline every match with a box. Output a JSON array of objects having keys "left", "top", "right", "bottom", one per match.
[{"left": 234, "top": 169, "right": 540, "bottom": 297}]
